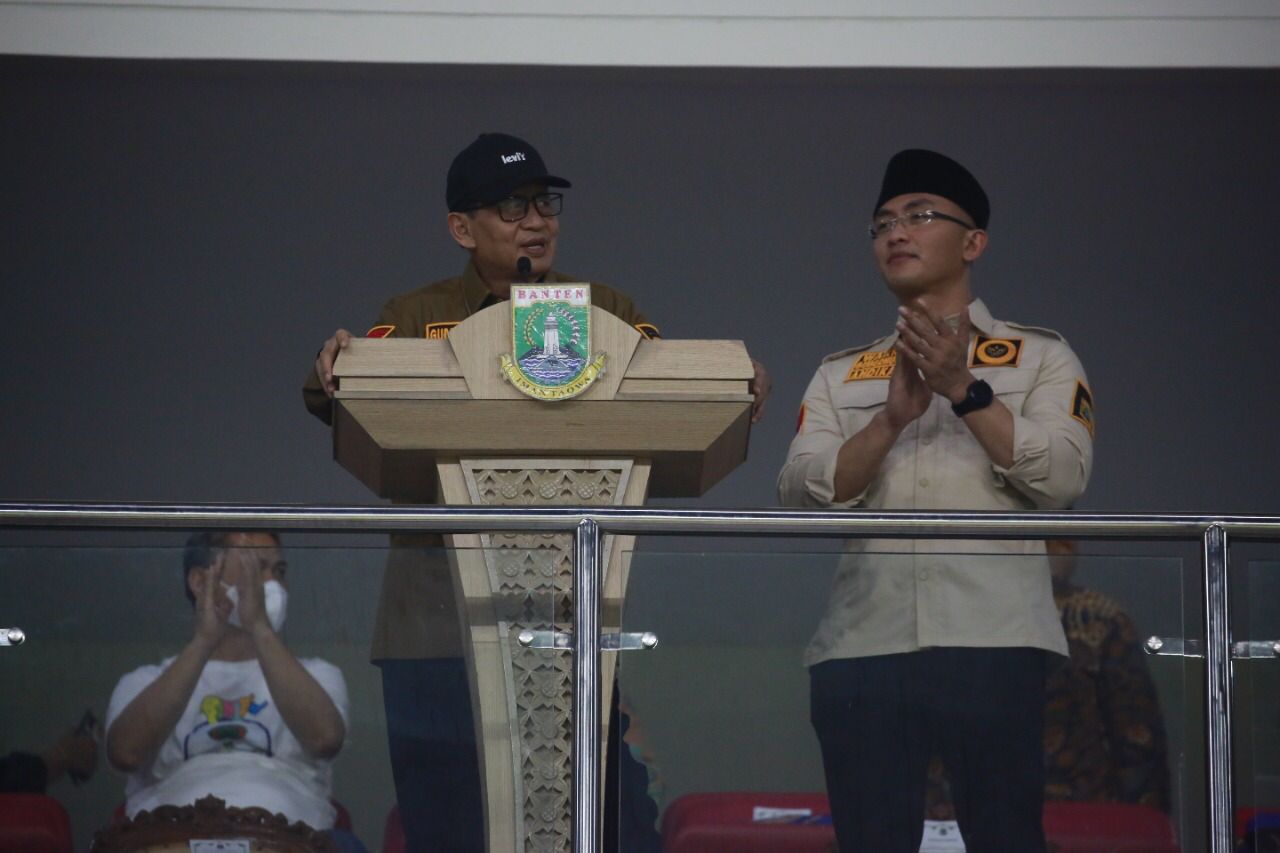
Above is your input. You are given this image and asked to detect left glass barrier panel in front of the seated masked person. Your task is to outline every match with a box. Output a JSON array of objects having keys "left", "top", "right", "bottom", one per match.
[{"left": 0, "top": 532, "right": 560, "bottom": 853}]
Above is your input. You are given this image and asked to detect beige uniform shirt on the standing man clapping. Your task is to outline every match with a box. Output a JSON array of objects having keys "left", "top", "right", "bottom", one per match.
[{"left": 778, "top": 301, "right": 1093, "bottom": 666}]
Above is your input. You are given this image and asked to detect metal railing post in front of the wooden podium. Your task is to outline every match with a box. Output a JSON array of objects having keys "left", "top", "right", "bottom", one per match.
[{"left": 573, "top": 519, "right": 603, "bottom": 853}]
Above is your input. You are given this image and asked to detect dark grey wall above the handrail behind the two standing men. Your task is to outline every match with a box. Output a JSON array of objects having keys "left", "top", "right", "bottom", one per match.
[{"left": 0, "top": 58, "right": 1280, "bottom": 512}]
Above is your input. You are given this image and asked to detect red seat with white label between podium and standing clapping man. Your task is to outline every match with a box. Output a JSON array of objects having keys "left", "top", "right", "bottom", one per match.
[{"left": 665, "top": 792, "right": 836, "bottom": 853}]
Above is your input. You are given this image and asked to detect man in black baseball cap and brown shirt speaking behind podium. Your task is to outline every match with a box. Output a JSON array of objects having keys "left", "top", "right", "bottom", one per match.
[{"left": 303, "top": 133, "right": 696, "bottom": 853}]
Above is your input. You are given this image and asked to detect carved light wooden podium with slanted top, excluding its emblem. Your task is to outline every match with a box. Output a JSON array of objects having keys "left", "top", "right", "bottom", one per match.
[{"left": 334, "top": 302, "right": 753, "bottom": 853}]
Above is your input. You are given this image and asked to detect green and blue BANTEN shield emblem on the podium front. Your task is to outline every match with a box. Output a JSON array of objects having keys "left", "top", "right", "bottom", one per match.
[{"left": 502, "top": 284, "right": 604, "bottom": 400}]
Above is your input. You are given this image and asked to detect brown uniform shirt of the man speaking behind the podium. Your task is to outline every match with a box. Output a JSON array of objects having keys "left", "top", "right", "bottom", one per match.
[{"left": 302, "top": 263, "right": 658, "bottom": 661}]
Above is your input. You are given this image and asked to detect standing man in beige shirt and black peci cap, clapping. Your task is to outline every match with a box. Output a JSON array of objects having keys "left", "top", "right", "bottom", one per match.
[{"left": 778, "top": 150, "right": 1093, "bottom": 853}]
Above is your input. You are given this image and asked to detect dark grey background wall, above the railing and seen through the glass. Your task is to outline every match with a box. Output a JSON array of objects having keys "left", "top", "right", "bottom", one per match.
[{"left": 0, "top": 56, "right": 1280, "bottom": 850}]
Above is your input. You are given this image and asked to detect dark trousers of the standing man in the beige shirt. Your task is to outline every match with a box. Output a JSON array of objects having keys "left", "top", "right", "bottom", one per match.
[{"left": 809, "top": 648, "right": 1047, "bottom": 853}]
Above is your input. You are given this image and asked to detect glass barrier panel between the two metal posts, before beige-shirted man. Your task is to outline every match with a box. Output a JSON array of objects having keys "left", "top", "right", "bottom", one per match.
[{"left": 605, "top": 538, "right": 1206, "bottom": 853}]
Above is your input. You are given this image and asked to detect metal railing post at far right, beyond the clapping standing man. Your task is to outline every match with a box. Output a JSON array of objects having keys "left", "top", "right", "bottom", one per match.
[{"left": 1203, "top": 524, "right": 1234, "bottom": 853}]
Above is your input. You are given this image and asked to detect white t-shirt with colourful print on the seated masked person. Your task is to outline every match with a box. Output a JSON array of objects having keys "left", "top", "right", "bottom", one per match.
[{"left": 106, "top": 657, "right": 347, "bottom": 830}]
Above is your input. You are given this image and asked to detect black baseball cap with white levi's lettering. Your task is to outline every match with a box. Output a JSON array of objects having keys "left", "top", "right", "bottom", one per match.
[{"left": 444, "top": 133, "right": 573, "bottom": 210}]
